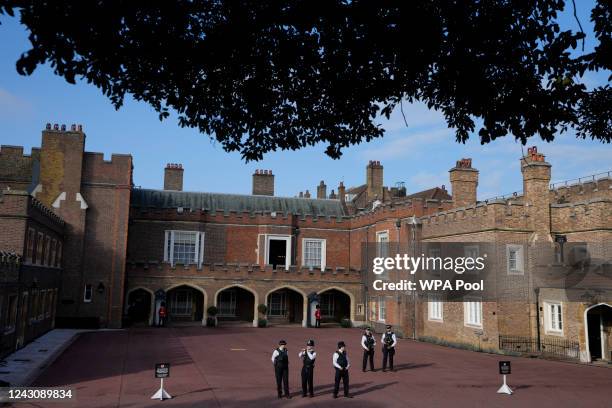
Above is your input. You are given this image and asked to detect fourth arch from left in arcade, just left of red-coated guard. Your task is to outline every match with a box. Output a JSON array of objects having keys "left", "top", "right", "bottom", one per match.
[{"left": 266, "top": 287, "right": 306, "bottom": 325}]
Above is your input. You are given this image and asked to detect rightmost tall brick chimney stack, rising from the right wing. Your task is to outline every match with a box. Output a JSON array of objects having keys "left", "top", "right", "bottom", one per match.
[{"left": 521, "top": 146, "right": 552, "bottom": 242}]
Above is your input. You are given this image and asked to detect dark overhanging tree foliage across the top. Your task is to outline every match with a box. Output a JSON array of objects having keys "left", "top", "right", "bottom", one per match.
[{"left": 0, "top": 0, "right": 612, "bottom": 160}]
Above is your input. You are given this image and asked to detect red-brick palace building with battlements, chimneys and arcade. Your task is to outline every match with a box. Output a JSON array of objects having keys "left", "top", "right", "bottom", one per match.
[{"left": 0, "top": 125, "right": 612, "bottom": 361}]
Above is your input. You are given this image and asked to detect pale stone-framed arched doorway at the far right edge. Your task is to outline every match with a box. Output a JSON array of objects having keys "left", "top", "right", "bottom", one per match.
[{"left": 585, "top": 303, "right": 612, "bottom": 362}]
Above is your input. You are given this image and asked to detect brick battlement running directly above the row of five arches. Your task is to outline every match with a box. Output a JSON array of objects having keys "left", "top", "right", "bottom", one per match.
[{"left": 127, "top": 260, "right": 361, "bottom": 283}]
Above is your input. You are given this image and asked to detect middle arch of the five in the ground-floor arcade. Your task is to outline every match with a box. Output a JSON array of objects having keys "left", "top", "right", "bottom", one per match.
[{"left": 215, "top": 286, "right": 256, "bottom": 325}]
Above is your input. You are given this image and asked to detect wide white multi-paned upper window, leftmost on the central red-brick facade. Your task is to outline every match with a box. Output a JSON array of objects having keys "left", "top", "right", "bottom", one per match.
[{"left": 164, "top": 231, "right": 204, "bottom": 266}]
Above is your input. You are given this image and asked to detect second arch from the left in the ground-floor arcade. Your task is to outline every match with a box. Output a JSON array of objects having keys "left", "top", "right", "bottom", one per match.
[{"left": 166, "top": 285, "right": 204, "bottom": 323}]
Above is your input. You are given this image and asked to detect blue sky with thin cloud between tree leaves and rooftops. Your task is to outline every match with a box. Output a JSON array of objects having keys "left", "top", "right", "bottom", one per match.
[{"left": 0, "top": 1, "right": 612, "bottom": 199}]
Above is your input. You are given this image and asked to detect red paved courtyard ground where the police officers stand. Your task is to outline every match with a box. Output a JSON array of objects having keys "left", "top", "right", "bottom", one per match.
[{"left": 21, "top": 327, "right": 612, "bottom": 408}]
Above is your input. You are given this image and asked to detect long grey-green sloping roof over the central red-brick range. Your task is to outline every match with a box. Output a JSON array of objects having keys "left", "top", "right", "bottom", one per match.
[{"left": 130, "top": 188, "right": 347, "bottom": 217}]
